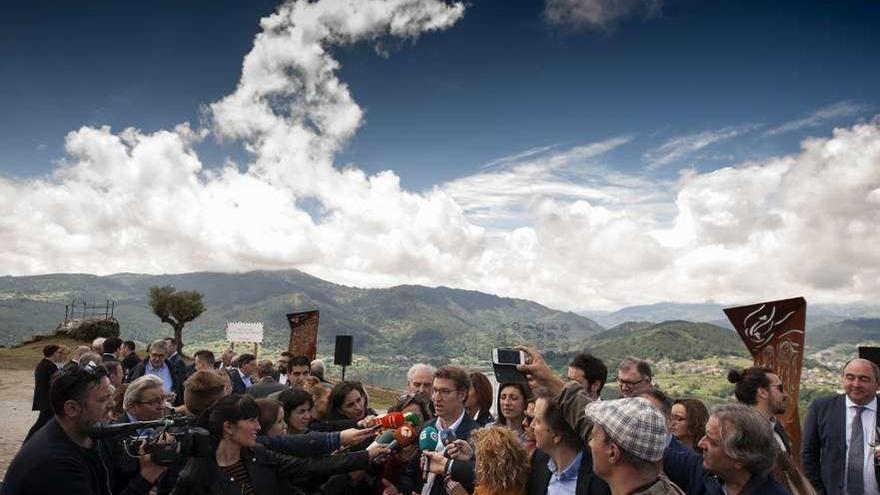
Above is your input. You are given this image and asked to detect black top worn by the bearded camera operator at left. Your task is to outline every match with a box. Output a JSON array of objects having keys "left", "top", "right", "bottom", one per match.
[{"left": 0, "top": 418, "right": 151, "bottom": 495}]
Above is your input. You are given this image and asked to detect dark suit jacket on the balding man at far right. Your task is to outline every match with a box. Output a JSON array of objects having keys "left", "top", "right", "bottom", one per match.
[{"left": 801, "top": 395, "right": 880, "bottom": 494}]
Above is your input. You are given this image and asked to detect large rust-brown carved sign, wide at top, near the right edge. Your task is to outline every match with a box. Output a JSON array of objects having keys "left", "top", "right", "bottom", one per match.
[{"left": 724, "top": 297, "right": 807, "bottom": 462}]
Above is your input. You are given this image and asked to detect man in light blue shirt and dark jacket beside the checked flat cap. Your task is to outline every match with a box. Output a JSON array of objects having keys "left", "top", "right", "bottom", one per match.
[{"left": 526, "top": 397, "right": 611, "bottom": 495}]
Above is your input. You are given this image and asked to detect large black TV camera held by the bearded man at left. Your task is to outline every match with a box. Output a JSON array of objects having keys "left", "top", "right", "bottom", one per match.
[{"left": 89, "top": 415, "right": 214, "bottom": 466}]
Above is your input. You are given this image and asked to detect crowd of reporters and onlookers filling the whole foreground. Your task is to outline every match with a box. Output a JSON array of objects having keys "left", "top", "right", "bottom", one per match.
[{"left": 0, "top": 337, "right": 880, "bottom": 495}]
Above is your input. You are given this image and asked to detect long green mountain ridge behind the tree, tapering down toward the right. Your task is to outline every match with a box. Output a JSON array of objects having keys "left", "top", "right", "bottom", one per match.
[{"left": 0, "top": 270, "right": 603, "bottom": 360}]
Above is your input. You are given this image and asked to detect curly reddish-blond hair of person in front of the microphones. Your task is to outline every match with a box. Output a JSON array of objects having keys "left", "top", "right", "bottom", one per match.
[{"left": 471, "top": 426, "right": 530, "bottom": 494}]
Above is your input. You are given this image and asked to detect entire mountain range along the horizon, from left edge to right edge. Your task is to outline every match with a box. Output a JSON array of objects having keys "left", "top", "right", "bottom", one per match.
[{"left": 0, "top": 270, "right": 880, "bottom": 362}]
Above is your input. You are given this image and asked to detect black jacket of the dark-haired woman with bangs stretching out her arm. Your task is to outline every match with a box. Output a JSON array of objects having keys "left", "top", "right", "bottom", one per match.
[{"left": 173, "top": 444, "right": 370, "bottom": 495}]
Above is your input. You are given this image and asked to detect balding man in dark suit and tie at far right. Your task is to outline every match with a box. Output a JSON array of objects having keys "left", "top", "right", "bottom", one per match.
[{"left": 801, "top": 358, "right": 880, "bottom": 495}]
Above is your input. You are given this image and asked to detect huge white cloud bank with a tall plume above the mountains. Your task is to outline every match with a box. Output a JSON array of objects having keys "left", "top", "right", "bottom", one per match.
[{"left": 0, "top": 0, "right": 880, "bottom": 309}]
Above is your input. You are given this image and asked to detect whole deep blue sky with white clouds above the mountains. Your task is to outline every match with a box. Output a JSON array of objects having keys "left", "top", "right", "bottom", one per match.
[{"left": 0, "top": 0, "right": 880, "bottom": 311}]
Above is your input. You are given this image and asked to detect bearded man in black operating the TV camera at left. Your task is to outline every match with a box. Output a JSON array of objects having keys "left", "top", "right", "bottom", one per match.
[{"left": 0, "top": 363, "right": 165, "bottom": 495}]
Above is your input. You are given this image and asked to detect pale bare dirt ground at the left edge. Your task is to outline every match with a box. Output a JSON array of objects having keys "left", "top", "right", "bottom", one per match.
[{"left": 0, "top": 368, "right": 37, "bottom": 479}]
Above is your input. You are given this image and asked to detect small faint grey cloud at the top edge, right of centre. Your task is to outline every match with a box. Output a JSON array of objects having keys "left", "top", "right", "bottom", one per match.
[{"left": 544, "top": 0, "right": 662, "bottom": 31}]
